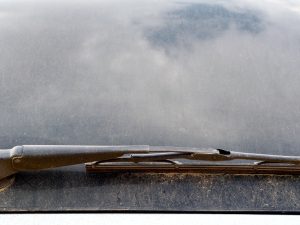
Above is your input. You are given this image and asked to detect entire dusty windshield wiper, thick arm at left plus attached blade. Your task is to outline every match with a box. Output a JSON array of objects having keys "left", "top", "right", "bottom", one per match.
[{"left": 0, "top": 145, "right": 300, "bottom": 189}]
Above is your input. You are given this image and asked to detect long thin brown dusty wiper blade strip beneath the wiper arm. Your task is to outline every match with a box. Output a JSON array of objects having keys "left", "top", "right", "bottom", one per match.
[{"left": 86, "top": 163, "right": 300, "bottom": 175}]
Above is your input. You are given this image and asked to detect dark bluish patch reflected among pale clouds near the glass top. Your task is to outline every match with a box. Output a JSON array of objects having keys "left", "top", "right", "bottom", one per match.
[{"left": 146, "top": 3, "right": 263, "bottom": 48}]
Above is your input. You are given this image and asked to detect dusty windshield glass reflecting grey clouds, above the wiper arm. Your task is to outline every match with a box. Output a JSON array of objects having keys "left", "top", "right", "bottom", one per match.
[{"left": 0, "top": 0, "right": 300, "bottom": 155}]
